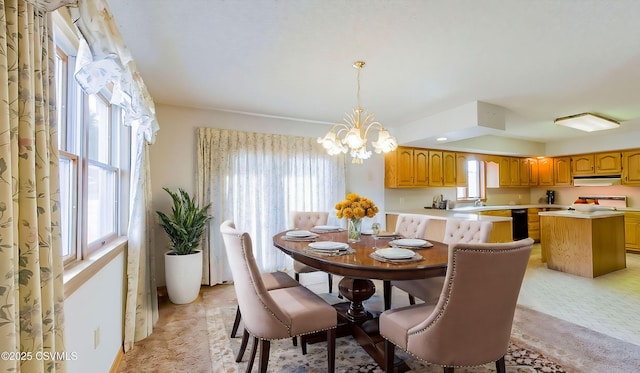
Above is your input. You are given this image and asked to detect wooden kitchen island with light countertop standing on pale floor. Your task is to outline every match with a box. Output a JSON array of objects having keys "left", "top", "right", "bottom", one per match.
[{"left": 539, "top": 210, "right": 627, "bottom": 278}]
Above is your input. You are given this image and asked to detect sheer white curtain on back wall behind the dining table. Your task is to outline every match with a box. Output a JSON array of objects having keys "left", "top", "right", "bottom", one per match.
[{"left": 197, "top": 128, "right": 346, "bottom": 285}]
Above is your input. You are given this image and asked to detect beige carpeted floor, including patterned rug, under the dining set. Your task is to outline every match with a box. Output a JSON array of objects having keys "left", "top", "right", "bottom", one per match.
[{"left": 118, "top": 285, "right": 640, "bottom": 373}]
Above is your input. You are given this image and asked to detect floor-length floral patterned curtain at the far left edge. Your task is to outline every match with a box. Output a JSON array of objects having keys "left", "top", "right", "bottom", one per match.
[{"left": 0, "top": 0, "right": 72, "bottom": 373}]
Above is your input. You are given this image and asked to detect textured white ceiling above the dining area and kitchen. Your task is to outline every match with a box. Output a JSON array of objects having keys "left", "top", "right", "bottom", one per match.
[{"left": 108, "top": 0, "right": 640, "bottom": 148}]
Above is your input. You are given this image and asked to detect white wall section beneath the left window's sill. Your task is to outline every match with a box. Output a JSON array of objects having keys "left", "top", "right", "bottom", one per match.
[{"left": 64, "top": 252, "right": 125, "bottom": 373}]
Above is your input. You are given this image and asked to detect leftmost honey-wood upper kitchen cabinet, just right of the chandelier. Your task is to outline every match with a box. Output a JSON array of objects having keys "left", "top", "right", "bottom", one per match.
[{"left": 384, "top": 146, "right": 429, "bottom": 188}]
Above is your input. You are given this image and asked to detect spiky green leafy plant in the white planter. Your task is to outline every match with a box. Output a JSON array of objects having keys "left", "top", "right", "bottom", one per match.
[{"left": 156, "top": 188, "right": 212, "bottom": 255}]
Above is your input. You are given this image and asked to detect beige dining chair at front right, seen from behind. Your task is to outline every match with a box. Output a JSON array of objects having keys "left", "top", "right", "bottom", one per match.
[{"left": 380, "top": 238, "right": 533, "bottom": 373}]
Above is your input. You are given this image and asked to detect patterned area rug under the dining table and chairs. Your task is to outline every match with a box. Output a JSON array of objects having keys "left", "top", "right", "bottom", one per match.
[{"left": 205, "top": 300, "right": 566, "bottom": 373}]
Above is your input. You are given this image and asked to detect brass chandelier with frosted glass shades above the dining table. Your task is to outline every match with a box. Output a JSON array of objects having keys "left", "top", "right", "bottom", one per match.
[{"left": 318, "top": 61, "right": 398, "bottom": 164}]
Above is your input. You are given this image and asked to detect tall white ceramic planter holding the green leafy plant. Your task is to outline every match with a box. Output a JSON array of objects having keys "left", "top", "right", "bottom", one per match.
[{"left": 164, "top": 251, "right": 202, "bottom": 304}]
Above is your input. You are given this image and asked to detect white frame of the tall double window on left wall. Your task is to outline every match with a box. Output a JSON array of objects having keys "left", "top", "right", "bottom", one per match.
[{"left": 54, "top": 13, "right": 131, "bottom": 268}]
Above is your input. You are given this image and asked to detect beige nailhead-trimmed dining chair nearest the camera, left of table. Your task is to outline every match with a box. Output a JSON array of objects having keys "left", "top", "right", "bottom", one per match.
[{"left": 220, "top": 220, "right": 338, "bottom": 372}]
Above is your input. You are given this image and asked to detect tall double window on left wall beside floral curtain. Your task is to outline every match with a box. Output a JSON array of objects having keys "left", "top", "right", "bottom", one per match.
[{"left": 54, "top": 17, "right": 131, "bottom": 265}]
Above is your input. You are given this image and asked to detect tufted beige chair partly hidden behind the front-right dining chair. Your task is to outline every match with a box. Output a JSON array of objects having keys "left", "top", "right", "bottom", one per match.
[{"left": 391, "top": 219, "right": 493, "bottom": 304}]
